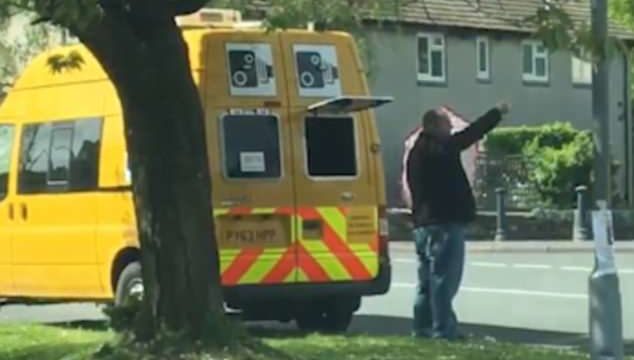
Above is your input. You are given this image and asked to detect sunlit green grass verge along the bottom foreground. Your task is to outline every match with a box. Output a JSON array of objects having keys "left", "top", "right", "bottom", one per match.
[{"left": 0, "top": 325, "right": 634, "bottom": 360}]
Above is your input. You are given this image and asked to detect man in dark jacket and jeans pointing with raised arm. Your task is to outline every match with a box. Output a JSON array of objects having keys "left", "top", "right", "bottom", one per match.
[{"left": 407, "top": 103, "right": 510, "bottom": 340}]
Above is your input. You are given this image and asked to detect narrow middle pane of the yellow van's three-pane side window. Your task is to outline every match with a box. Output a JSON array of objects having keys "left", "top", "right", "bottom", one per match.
[{"left": 46, "top": 123, "right": 73, "bottom": 189}]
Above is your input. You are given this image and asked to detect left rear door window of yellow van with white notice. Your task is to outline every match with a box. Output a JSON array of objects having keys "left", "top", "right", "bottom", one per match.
[{"left": 221, "top": 115, "right": 282, "bottom": 179}]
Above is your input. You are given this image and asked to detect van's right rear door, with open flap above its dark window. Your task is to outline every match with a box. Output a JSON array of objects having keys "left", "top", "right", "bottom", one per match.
[{"left": 280, "top": 32, "right": 390, "bottom": 283}]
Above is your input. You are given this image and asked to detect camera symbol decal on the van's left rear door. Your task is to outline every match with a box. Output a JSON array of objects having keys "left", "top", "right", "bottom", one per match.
[{"left": 227, "top": 43, "right": 276, "bottom": 96}]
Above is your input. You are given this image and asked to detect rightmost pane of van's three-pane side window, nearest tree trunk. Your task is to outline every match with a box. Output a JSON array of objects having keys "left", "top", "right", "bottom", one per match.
[{"left": 69, "top": 119, "right": 102, "bottom": 191}]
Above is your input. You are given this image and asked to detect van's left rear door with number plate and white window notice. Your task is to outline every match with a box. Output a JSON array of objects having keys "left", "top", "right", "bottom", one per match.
[{"left": 202, "top": 32, "right": 296, "bottom": 286}]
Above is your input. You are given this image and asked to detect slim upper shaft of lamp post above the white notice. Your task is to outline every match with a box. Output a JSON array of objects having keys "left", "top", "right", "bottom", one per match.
[{"left": 591, "top": 0, "right": 611, "bottom": 206}]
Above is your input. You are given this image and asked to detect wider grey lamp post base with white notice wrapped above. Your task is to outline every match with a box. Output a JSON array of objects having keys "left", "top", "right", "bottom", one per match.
[{"left": 588, "top": 201, "right": 624, "bottom": 360}]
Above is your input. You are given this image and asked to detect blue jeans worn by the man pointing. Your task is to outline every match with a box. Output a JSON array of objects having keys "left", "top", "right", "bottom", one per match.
[{"left": 414, "top": 224, "right": 465, "bottom": 339}]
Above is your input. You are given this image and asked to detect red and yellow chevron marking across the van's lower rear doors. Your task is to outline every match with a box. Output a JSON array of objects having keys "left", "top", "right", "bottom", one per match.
[{"left": 214, "top": 207, "right": 378, "bottom": 286}]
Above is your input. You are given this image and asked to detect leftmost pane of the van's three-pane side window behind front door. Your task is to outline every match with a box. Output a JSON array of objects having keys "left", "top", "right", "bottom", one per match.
[{"left": 18, "top": 124, "right": 51, "bottom": 194}]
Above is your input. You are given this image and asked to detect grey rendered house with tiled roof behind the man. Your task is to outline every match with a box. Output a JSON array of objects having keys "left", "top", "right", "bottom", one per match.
[{"left": 244, "top": 0, "right": 634, "bottom": 206}]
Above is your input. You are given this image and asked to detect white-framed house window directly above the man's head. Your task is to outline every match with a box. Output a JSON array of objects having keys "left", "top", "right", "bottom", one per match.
[{"left": 418, "top": 34, "right": 447, "bottom": 82}]
